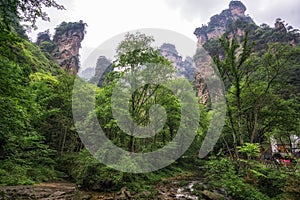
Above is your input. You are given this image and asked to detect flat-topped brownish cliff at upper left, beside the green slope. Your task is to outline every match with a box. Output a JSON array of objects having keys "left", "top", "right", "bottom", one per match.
[{"left": 36, "top": 21, "right": 86, "bottom": 74}]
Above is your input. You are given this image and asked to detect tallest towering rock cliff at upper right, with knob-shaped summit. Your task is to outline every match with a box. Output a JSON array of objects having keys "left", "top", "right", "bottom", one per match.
[{"left": 194, "top": 0, "right": 300, "bottom": 104}]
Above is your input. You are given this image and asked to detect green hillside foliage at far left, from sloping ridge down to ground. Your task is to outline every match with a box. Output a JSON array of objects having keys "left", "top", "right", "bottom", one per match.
[{"left": 0, "top": 22, "right": 59, "bottom": 184}]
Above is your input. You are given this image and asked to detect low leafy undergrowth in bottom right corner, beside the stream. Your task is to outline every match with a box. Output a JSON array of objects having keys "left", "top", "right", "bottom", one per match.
[{"left": 205, "top": 158, "right": 300, "bottom": 199}]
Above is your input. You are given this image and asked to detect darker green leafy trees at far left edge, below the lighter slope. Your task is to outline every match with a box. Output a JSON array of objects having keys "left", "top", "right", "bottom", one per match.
[{"left": 0, "top": 43, "right": 54, "bottom": 185}]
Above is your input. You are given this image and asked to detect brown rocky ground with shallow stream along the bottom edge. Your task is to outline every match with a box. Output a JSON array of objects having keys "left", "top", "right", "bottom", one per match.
[{"left": 0, "top": 174, "right": 230, "bottom": 200}]
